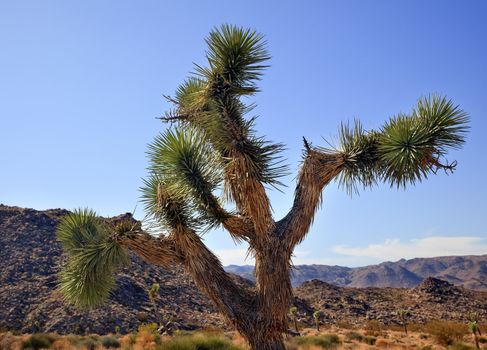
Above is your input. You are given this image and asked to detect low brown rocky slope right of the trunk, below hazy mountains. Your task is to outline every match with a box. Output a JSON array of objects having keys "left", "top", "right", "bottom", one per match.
[{"left": 294, "top": 277, "right": 487, "bottom": 324}]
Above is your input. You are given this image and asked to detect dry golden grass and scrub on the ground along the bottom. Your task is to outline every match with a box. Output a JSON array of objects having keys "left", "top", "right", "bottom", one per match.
[{"left": 0, "top": 321, "right": 487, "bottom": 350}]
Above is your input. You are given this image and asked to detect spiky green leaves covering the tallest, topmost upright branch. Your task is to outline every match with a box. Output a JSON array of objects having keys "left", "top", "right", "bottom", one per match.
[{"left": 167, "top": 25, "right": 287, "bottom": 186}]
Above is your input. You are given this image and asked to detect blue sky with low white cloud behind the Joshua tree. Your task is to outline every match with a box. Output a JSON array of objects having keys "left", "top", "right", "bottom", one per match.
[{"left": 0, "top": 0, "right": 487, "bottom": 266}]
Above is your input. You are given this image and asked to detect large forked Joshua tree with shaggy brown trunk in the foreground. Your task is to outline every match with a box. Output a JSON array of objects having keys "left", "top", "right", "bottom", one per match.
[{"left": 58, "top": 25, "right": 468, "bottom": 350}]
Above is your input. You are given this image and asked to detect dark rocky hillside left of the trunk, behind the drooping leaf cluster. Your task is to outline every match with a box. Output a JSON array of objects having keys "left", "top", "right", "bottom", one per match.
[{"left": 0, "top": 205, "right": 223, "bottom": 334}]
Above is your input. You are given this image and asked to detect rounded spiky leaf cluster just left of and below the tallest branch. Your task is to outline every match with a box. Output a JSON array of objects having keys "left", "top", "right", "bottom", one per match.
[{"left": 142, "top": 127, "right": 226, "bottom": 231}]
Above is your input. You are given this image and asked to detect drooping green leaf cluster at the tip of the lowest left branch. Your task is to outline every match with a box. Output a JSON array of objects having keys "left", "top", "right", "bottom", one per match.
[{"left": 57, "top": 209, "right": 128, "bottom": 307}]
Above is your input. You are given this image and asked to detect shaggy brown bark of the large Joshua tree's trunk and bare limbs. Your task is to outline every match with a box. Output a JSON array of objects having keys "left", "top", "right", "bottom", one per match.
[{"left": 116, "top": 149, "right": 343, "bottom": 350}]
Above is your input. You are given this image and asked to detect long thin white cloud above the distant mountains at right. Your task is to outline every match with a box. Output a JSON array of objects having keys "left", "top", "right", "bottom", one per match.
[{"left": 333, "top": 236, "right": 487, "bottom": 261}]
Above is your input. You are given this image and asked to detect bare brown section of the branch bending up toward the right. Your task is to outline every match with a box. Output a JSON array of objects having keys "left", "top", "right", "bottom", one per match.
[{"left": 276, "top": 145, "right": 343, "bottom": 251}]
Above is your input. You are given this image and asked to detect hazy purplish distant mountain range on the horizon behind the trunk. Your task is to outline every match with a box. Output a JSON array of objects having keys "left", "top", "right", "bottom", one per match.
[{"left": 226, "top": 254, "right": 487, "bottom": 290}]
